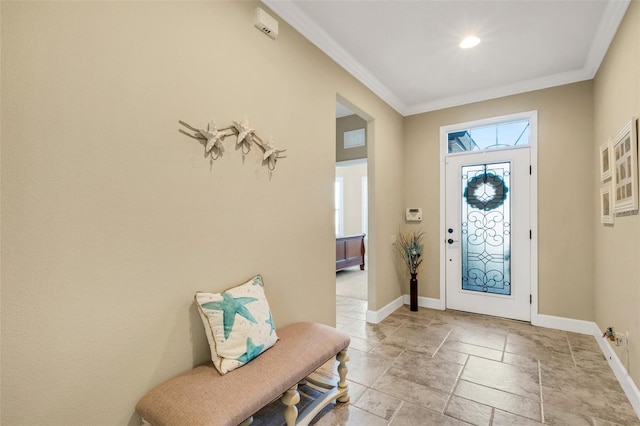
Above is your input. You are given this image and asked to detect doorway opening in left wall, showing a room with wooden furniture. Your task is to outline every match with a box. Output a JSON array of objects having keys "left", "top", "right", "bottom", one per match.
[{"left": 334, "top": 102, "right": 369, "bottom": 326}]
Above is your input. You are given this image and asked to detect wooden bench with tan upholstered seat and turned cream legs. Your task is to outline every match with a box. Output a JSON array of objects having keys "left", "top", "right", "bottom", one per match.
[{"left": 136, "top": 322, "right": 350, "bottom": 426}]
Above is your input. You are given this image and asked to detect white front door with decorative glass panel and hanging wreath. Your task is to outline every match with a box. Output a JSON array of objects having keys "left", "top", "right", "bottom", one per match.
[{"left": 443, "top": 147, "right": 531, "bottom": 321}]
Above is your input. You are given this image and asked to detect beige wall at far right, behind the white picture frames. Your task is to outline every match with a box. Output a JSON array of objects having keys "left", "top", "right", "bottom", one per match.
[{"left": 591, "top": 1, "right": 640, "bottom": 385}]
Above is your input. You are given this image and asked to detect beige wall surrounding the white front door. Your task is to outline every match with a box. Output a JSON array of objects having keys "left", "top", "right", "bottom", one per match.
[{"left": 403, "top": 82, "right": 595, "bottom": 320}]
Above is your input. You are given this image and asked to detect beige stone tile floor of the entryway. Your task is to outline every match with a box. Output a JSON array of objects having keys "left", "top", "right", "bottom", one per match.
[{"left": 314, "top": 296, "right": 640, "bottom": 426}]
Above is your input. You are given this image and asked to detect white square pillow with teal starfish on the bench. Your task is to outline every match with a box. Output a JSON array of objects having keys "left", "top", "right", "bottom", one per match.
[{"left": 195, "top": 275, "right": 278, "bottom": 374}]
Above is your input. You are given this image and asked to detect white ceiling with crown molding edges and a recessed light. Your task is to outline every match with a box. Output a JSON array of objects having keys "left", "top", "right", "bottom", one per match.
[{"left": 262, "top": 0, "right": 630, "bottom": 116}]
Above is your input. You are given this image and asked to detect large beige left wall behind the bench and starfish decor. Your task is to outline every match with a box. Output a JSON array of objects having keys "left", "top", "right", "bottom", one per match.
[{"left": 0, "top": 2, "right": 402, "bottom": 425}]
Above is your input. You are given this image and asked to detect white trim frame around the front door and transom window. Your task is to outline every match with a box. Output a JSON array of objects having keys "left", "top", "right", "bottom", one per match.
[{"left": 439, "top": 110, "right": 538, "bottom": 325}]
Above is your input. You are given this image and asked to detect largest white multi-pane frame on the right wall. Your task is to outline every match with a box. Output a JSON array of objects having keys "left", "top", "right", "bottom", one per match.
[{"left": 611, "top": 117, "right": 638, "bottom": 214}]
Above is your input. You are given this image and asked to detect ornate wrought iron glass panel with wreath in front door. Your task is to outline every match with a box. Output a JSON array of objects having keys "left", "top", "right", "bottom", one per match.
[{"left": 461, "top": 162, "right": 511, "bottom": 296}]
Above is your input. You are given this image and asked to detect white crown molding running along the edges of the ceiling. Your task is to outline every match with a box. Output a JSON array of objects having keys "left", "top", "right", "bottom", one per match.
[{"left": 261, "top": 0, "right": 631, "bottom": 117}]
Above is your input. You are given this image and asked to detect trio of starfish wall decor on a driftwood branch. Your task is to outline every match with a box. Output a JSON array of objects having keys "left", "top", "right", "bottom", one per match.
[{"left": 178, "top": 118, "right": 286, "bottom": 172}]
